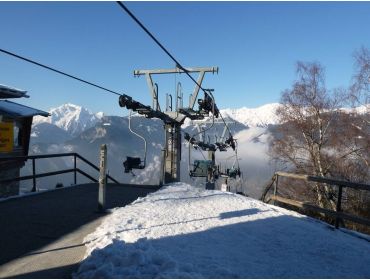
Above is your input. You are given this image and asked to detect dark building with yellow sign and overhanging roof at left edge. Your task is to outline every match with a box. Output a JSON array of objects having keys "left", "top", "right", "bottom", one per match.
[{"left": 0, "top": 85, "right": 49, "bottom": 197}]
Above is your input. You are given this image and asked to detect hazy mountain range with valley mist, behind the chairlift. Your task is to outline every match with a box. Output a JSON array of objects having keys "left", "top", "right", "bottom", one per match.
[{"left": 26, "top": 103, "right": 368, "bottom": 198}]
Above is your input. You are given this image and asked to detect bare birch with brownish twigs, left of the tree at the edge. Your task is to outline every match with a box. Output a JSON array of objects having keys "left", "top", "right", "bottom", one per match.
[{"left": 271, "top": 62, "right": 370, "bottom": 210}]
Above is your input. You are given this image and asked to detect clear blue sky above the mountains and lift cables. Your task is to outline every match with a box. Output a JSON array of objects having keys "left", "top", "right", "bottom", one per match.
[{"left": 0, "top": 2, "right": 370, "bottom": 114}]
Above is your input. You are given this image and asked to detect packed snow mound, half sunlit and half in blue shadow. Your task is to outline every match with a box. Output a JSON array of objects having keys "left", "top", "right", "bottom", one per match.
[{"left": 74, "top": 183, "right": 370, "bottom": 278}]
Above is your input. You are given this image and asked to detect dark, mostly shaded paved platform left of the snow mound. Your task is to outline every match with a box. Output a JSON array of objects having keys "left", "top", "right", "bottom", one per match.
[{"left": 0, "top": 184, "right": 156, "bottom": 278}]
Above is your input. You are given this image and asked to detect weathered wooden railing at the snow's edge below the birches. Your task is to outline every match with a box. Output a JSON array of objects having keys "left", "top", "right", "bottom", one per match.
[{"left": 261, "top": 172, "right": 370, "bottom": 228}]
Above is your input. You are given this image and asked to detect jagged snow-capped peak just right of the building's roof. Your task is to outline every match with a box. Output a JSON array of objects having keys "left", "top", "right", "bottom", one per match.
[{"left": 33, "top": 103, "right": 104, "bottom": 136}]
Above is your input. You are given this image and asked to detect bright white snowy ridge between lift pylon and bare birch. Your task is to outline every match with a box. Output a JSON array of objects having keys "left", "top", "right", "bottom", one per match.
[{"left": 220, "top": 103, "right": 280, "bottom": 127}]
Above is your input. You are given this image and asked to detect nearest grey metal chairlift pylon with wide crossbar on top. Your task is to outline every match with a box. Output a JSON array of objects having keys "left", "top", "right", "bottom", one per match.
[{"left": 119, "top": 67, "right": 219, "bottom": 183}]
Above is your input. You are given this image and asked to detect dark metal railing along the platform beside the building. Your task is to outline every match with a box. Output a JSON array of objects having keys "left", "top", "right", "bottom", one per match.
[{"left": 0, "top": 153, "right": 119, "bottom": 192}]
